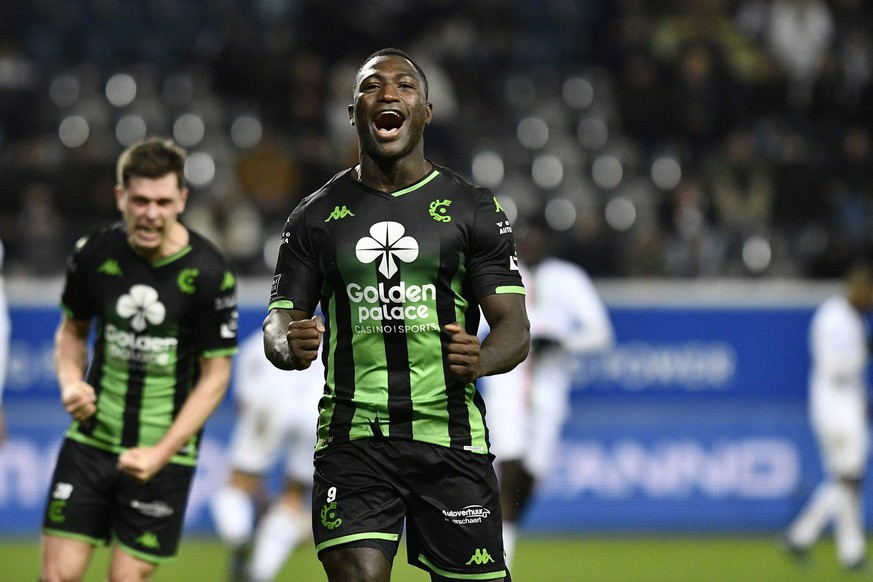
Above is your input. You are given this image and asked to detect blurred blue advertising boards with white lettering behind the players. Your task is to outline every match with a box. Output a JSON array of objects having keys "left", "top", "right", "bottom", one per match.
[{"left": 0, "top": 282, "right": 852, "bottom": 536}]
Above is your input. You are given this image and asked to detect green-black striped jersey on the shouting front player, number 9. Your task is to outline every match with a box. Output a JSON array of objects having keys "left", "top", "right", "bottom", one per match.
[{"left": 270, "top": 166, "right": 524, "bottom": 454}]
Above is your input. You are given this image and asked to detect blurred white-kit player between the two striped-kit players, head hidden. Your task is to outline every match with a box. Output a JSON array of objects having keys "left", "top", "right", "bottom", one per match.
[{"left": 211, "top": 329, "right": 324, "bottom": 582}]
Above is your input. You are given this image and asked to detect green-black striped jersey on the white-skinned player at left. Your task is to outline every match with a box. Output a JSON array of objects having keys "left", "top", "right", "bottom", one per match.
[{"left": 61, "top": 224, "right": 238, "bottom": 465}]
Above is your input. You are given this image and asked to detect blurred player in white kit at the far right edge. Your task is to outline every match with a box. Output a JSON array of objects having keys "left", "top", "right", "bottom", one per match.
[{"left": 785, "top": 265, "right": 873, "bottom": 569}]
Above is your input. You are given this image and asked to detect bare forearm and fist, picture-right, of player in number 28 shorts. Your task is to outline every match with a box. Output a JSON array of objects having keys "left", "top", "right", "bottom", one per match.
[{"left": 118, "top": 356, "right": 231, "bottom": 482}]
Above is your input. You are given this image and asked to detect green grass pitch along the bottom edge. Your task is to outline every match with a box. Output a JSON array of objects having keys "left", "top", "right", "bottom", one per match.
[{"left": 0, "top": 534, "right": 873, "bottom": 582}]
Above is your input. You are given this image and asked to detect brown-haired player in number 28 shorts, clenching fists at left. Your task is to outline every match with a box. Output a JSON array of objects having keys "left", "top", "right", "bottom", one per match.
[{"left": 41, "top": 138, "right": 237, "bottom": 582}]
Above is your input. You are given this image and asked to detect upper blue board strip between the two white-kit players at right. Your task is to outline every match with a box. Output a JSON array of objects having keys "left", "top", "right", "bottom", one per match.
[{"left": 576, "top": 306, "right": 812, "bottom": 398}]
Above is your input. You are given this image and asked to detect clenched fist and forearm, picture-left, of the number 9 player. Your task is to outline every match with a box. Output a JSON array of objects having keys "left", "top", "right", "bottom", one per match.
[{"left": 263, "top": 308, "right": 324, "bottom": 370}]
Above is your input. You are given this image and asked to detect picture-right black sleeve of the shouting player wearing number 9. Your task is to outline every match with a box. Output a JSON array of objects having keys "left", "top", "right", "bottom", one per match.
[{"left": 467, "top": 191, "right": 524, "bottom": 299}]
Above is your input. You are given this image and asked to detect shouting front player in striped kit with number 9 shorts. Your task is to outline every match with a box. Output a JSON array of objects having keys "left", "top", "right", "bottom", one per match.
[{"left": 264, "top": 49, "right": 529, "bottom": 581}]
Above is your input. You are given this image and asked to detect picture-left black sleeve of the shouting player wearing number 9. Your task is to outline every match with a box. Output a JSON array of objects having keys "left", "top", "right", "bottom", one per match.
[{"left": 269, "top": 200, "right": 322, "bottom": 314}]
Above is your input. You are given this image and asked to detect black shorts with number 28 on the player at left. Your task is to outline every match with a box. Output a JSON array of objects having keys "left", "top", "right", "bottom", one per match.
[{"left": 42, "top": 439, "right": 194, "bottom": 563}]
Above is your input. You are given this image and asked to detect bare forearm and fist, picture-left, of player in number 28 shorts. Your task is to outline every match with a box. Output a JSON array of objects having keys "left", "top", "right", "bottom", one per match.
[{"left": 55, "top": 313, "right": 97, "bottom": 420}]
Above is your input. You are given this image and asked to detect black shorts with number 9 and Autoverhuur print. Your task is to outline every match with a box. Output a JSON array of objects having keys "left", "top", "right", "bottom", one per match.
[{"left": 312, "top": 438, "right": 508, "bottom": 579}]
